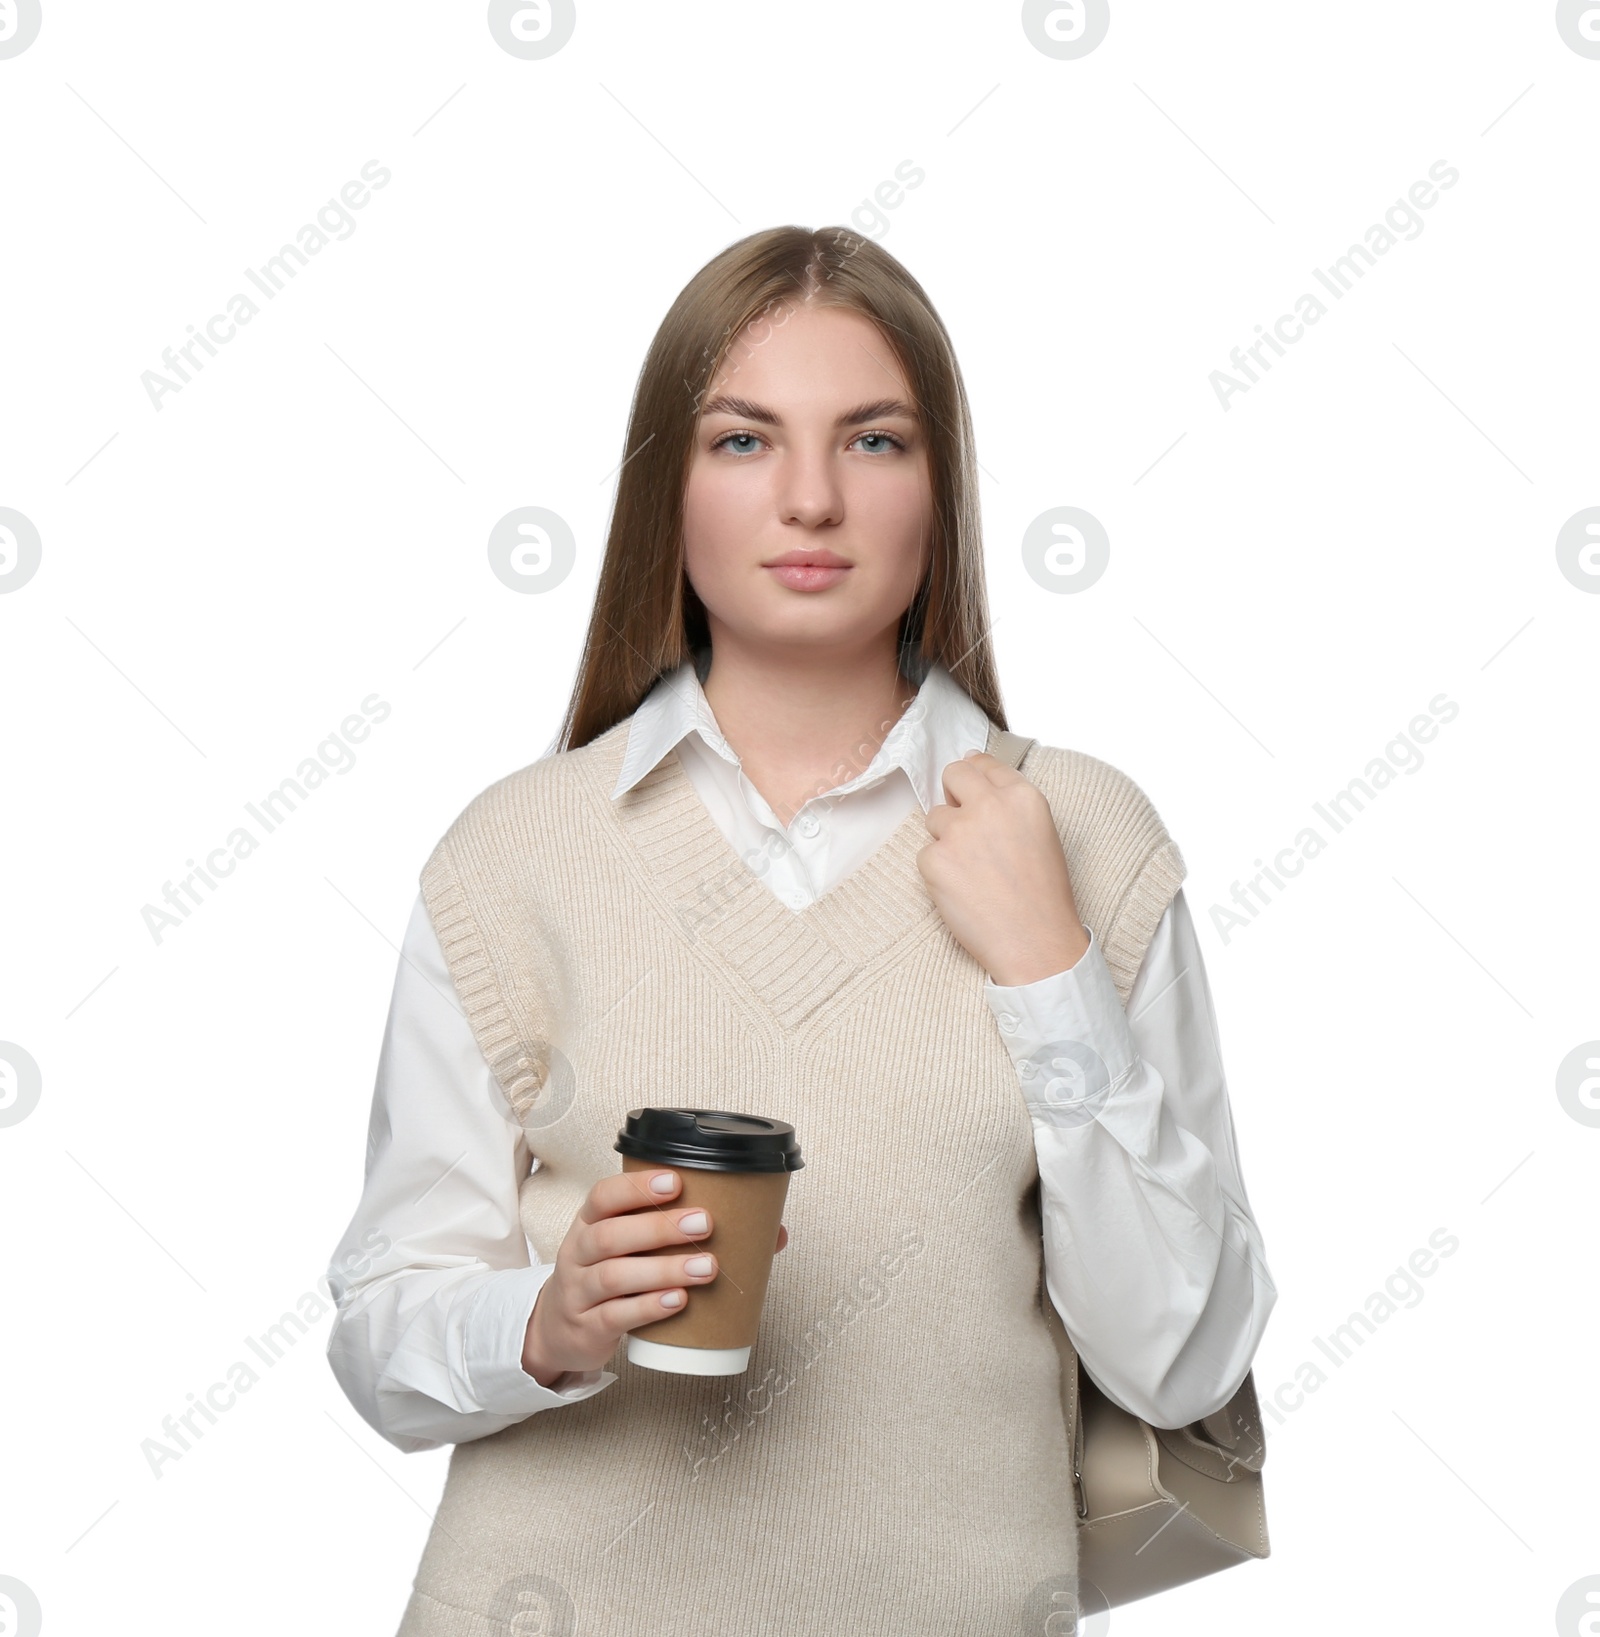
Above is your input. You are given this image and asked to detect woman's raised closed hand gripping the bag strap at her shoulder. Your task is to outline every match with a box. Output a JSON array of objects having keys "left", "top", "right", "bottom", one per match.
[{"left": 917, "top": 751, "right": 1089, "bottom": 987}]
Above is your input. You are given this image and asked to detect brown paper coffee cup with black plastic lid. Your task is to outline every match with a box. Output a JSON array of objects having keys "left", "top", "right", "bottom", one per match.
[{"left": 612, "top": 1108, "right": 804, "bottom": 1375}]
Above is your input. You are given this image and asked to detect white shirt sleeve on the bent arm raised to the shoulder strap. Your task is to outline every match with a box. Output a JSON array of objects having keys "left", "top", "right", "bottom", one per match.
[{"left": 984, "top": 892, "right": 1277, "bottom": 1427}]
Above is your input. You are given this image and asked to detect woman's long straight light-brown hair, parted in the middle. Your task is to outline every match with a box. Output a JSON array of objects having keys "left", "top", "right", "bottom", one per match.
[{"left": 557, "top": 228, "right": 1007, "bottom": 750}]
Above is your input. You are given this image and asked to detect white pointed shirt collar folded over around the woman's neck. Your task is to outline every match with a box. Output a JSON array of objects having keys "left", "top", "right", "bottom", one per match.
[{"left": 611, "top": 660, "right": 989, "bottom": 812}]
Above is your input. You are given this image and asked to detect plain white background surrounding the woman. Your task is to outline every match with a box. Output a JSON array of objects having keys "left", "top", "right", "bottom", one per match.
[{"left": 0, "top": 0, "right": 1600, "bottom": 1637}]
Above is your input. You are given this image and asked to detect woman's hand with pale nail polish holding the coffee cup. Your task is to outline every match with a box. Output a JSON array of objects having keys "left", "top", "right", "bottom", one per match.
[{"left": 522, "top": 1170, "right": 789, "bottom": 1387}]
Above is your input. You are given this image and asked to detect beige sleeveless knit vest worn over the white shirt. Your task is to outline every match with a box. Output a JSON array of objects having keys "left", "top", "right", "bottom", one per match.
[{"left": 400, "top": 719, "right": 1184, "bottom": 1637}]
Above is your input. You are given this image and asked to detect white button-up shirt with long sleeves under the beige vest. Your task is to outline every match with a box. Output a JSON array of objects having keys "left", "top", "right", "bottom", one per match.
[{"left": 328, "top": 661, "right": 1277, "bottom": 1450}]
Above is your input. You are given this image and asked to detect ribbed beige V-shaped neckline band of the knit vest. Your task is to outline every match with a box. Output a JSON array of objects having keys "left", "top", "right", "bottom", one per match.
[{"left": 594, "top": 722, "right": 996, "bottom": 1028}]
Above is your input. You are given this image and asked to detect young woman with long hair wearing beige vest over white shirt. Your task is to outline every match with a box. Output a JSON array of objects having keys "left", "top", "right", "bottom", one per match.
[{"left": 329, "top": 228, "right": 1276, "bottom": 1637}]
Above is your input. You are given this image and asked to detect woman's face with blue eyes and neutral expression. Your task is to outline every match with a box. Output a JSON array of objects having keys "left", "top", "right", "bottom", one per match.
[{"left": 683, "top": 304, "right": 932, "bottom": 655}]
